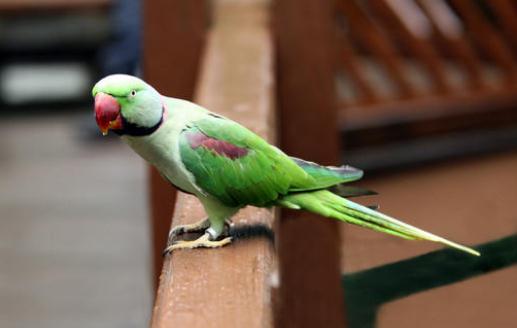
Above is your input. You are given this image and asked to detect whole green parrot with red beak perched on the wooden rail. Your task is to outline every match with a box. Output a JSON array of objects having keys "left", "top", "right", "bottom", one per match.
[{"left": 92, "top": 74, "right": 479, "bottom": 256}]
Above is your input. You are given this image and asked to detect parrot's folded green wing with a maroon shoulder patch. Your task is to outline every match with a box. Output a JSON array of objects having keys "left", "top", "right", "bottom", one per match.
[{"left": 179, "top": 115, "right": 316, "bottom": 206}]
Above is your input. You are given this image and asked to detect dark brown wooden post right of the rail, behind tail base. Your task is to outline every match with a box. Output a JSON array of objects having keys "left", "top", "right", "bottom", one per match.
[{"left": 275, "top": 0, "right": 345, "bottom": 328}]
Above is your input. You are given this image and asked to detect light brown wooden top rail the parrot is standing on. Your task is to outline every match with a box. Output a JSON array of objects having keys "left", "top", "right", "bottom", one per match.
[{"left": 151, "top": 0, "right": 274, "bottom": 328}]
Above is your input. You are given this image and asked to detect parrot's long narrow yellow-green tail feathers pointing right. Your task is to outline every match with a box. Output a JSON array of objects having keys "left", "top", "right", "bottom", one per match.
[{"left": 277, "top": 190, "right": 480, "bottom": 256}]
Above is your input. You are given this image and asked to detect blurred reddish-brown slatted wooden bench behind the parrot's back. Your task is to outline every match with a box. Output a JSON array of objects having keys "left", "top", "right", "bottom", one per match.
[{"left": 337, "top": 0, "right": 517, "bottom": 171}]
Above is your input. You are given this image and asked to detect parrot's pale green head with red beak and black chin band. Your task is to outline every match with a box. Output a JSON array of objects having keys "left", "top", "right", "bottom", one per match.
[{"left": 92, "top": 74, "right": 164, "bottom": 136}]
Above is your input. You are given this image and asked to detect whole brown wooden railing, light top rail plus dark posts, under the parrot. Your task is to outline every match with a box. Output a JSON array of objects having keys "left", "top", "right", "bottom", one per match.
[{"left": 146, "top": 0, "right": 344, "bottom": 327}]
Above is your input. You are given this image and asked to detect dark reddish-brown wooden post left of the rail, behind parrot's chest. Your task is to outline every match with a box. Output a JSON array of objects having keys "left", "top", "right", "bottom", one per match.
[{"left": 143, "top": 0, "right": 207, "bottom": 286}]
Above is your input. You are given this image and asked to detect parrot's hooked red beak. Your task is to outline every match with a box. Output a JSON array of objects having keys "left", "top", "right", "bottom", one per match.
[{"left": 95, "top": 92, "right": 122, "bottom": 135}]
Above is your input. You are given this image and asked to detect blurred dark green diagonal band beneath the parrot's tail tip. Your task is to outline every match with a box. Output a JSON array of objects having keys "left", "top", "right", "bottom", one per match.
[{"left": 342, "top": 235, "right": 517, "bottom": 328}]
